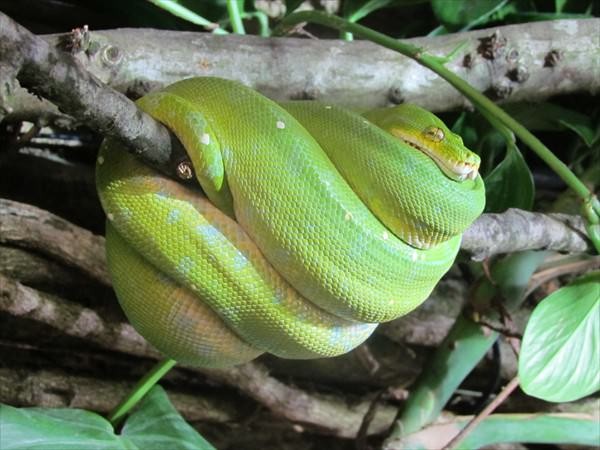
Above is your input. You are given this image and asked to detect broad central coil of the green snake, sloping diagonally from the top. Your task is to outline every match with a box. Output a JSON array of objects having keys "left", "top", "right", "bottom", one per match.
[{"left": 145, "top": 78, "right": 460, "bottom": 322}]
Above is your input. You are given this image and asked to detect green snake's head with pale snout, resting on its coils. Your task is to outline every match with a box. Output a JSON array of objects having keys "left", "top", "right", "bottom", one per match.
[{"left": 365, "top": 103, "right": 481, "bottom": 181}]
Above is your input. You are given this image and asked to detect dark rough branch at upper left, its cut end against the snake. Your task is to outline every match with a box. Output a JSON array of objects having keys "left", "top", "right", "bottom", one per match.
[{"left": 0, "top": 12, "right": 185, "bottom": 178}]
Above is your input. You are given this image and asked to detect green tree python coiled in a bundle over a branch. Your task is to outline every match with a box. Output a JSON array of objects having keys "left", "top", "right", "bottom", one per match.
[{"left": 96, "top": 78, "right": 484, "bottom": 367}]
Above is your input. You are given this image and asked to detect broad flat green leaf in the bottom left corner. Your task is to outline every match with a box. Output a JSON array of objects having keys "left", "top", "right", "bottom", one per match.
[{"left": 0, "top": 405, "right": 132, "bottom": 450}]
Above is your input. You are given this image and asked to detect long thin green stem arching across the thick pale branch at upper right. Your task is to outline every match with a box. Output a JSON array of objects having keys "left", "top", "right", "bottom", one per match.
[{"left": 273, "top": 11, "right": 600, "bottom": 253}]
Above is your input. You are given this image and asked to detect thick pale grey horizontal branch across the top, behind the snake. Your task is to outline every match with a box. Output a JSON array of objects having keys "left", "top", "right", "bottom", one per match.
[{"left": 0, "top": 14, "right": 600, "bottom": 118}]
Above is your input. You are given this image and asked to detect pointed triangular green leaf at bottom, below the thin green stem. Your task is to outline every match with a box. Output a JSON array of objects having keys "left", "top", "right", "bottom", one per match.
[{"left": 121, "top": 385, "right": 215, "bottom": 450}]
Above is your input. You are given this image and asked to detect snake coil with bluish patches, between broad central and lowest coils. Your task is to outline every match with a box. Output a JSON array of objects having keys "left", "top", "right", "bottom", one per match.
[{"left": 97, "top": 141, "right": 375, "bottom": 358}]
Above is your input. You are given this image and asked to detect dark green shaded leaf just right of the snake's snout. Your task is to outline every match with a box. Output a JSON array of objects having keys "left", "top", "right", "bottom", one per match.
[{"left": 485, "top": 142, "right": 535, "bottom": 213}]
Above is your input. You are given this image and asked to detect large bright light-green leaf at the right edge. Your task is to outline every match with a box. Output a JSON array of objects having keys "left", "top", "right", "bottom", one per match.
[{"left": 519, "top": 272, "right": 600, "bottom": 402}]
